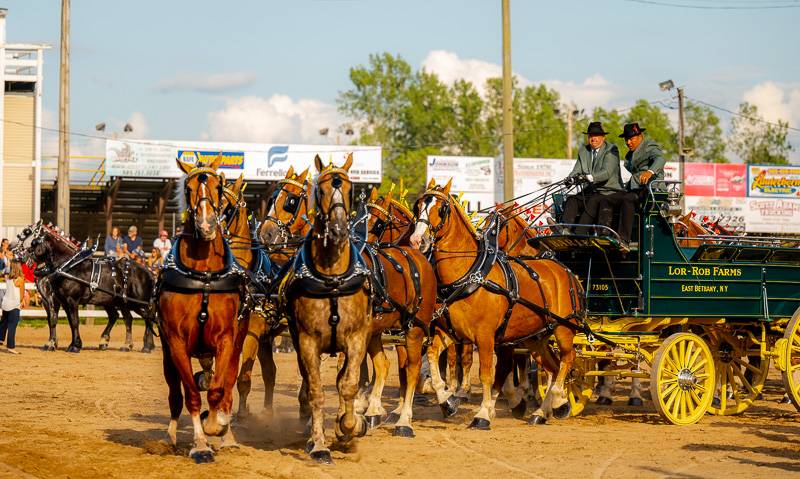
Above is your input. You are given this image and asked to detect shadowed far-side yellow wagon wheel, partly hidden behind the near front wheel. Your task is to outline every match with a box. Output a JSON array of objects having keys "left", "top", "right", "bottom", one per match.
[{"left": 705, "top": 329, "right": 769, "bottom": 416}]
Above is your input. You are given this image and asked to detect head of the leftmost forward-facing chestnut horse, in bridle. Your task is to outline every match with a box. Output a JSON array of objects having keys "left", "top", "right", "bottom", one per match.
[{"left": 176, "top": 155, "right": 225, "bottom": 241}]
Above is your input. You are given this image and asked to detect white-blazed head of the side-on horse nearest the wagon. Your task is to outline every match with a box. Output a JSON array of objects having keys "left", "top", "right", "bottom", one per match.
[{"left": 409, "top": 178, "right": 455, "bottom": 253}]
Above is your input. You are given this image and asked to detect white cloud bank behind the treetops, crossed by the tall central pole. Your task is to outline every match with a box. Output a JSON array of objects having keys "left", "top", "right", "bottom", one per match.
[{"left": 422, "top": 50, "right": 616, "bottom": 110}]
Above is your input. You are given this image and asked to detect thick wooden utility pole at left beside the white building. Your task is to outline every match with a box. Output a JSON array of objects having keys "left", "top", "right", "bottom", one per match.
[{"left": 56, "top": 0, "right": 70, "bottom": 232}]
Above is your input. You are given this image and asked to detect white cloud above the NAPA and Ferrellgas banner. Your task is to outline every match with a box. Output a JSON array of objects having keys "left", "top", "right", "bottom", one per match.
[{"left": 203, "top": 95, "right": 341, "bottom": 143}]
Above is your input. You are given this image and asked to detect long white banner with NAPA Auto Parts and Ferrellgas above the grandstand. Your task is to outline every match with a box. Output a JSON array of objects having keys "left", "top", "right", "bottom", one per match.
[{"left": 106, "top": 140, "right": 382, "bottom": 183}]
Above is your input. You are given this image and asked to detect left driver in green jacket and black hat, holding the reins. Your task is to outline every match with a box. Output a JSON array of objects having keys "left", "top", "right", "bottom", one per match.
[{"left": 561, "top": 121, "right": 623, "bottom": 234}]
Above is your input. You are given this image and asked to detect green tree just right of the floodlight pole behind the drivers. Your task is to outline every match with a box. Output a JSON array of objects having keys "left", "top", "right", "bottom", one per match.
[{"left": 684, "top": 102, "right": 728, "bottom": 163}]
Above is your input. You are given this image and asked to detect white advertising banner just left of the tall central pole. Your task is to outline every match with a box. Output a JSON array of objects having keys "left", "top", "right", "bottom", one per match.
[{"left": 425, "top": 155, "right": 495, "bottom": 212}]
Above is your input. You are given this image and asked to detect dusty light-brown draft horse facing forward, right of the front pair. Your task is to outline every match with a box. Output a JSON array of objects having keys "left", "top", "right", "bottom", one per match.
[{"left": 278, "top": 154, "right": 372, "bottom": 463}]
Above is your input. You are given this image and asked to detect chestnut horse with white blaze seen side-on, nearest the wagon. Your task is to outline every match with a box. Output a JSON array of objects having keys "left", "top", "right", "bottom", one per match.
[{"left": 411, "top": 181, "right": 583, "bottom": 429}]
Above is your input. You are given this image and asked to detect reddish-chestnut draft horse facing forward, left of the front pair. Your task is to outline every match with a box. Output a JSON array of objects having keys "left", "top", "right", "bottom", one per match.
[{"left": 156, "top": 155, "right": 247, "bottom": 463}]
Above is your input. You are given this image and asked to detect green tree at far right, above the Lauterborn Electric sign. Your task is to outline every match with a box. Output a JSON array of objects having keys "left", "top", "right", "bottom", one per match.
[{"left": 728, "top": 102, "right": 792, "bottom": 165}]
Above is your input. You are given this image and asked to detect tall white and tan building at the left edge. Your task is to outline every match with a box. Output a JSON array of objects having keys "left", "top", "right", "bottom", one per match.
[{"left": 0, "top": 8, "right": 50, "bottom": 238}]
